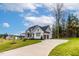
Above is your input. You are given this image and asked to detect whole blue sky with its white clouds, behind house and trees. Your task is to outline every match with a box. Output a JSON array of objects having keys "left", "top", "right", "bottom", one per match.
[{"left": 0, "top": 3, "right": 79, "bottom": 34}]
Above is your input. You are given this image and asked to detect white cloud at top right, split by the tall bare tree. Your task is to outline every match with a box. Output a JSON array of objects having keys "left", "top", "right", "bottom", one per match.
[{"left": 44, "top": 3, "right": 79, "bottom": 11}]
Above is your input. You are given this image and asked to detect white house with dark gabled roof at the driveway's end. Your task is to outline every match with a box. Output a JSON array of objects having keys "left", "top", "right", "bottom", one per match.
[{"left": 26, "top": 25, "right": 52, "bottom": 39}]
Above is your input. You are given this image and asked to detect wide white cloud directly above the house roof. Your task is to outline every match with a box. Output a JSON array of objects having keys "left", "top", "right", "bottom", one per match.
[{"left": 24, "top": 16, "right": 55, "bottom": 26}]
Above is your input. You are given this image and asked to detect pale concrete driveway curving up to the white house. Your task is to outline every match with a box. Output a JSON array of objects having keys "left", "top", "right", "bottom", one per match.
[{"left": 0, "top": 39, "right": 67, "bottom": 56}]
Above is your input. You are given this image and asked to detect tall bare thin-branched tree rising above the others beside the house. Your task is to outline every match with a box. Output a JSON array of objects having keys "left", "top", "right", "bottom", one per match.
[{"left": 54, "top": 3, "right": 64, "bottom": 38}]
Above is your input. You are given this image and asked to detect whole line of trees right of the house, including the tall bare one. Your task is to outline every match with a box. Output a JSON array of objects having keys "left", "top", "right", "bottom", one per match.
[{"left": 52, "top": 3, "right": 79, "bottom": 38}]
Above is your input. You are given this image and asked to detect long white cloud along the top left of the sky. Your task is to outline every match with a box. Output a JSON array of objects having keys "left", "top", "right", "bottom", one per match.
[{"left": 0, "top": 3, "right": 40, "bottom": 12}]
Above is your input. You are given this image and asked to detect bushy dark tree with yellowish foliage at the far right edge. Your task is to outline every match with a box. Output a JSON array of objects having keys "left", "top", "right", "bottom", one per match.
[{"left": 66, "top": 14, "right": 79, "bottom": 37}]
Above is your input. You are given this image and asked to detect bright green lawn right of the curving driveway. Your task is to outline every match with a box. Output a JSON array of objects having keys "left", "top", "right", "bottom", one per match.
[{"left": 49, "top": 38, "right": 79, "bottom": 56}]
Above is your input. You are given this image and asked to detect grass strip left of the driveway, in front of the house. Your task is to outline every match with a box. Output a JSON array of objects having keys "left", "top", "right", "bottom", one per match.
[{"left": 0, "top": 40, "right": 41, "bottom": 52}]
